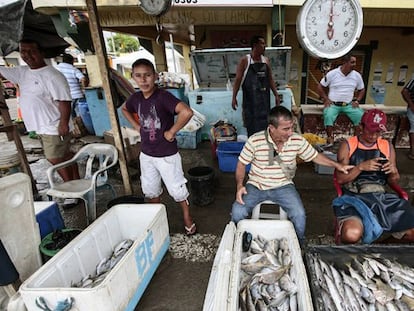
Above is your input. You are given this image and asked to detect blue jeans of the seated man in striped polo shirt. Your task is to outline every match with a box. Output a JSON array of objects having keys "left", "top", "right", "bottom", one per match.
[{"left": 231, "top": 184, "right": 306, "bottom": 242}]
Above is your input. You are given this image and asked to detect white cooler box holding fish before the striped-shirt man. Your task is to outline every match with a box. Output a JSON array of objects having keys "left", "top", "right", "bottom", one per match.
[{"left": 203, "top": 219, "right": 314, "bottom": 311}]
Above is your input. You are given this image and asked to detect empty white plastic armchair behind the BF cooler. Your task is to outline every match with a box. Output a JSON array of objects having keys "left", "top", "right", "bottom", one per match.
[{"left": 47, "top": 143, "right": 118, "bottom": 225}]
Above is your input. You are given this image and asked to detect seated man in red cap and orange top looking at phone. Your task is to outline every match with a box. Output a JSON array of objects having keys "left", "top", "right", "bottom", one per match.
[{"left": 333, "top": 109, "right": 414, "bottom": 243}]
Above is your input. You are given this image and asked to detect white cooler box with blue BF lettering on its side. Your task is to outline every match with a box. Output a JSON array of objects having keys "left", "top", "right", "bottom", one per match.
[{"left": 20, "top": 204, "right": 170, "bottom": 311}]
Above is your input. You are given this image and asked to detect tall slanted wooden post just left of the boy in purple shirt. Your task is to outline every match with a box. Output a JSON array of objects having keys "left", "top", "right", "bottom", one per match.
[{"left": 85, "top": 0, "right": 132, "bottom": 194}]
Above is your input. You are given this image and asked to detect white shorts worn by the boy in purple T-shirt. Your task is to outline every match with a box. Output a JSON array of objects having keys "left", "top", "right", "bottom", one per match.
[{"left": 139, "top": 152, "right": 190, "bottom": 202}]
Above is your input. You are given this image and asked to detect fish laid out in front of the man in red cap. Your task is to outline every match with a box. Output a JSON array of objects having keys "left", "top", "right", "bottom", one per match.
[{"left": 308, "top": 254, "right": 414, "bottom": 311}]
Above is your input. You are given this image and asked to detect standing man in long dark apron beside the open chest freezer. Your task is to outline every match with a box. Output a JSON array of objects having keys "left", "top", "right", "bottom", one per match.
[{"left": 231, "top": 36, "right": 280, "bottom": 136}]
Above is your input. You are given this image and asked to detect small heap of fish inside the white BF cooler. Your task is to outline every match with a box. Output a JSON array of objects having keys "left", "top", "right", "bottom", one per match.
[{"left": 71, "top": 239, "right": 134, "bottom": 288}]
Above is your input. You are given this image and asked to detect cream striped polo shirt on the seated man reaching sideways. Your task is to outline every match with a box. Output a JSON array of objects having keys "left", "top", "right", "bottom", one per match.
[{"left": 239, "top": 128, "right": 318, "bottom": 190}]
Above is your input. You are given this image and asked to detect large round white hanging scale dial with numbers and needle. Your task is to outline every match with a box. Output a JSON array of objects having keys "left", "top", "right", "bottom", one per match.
[{"left": 296, "top": 0, "right": 363, "bottom": 59}]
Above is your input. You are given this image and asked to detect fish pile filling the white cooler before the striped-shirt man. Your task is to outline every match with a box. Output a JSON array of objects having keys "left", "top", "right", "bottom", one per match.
[{"left": 239, "top": 235, "right": 298, "bottom": 311}]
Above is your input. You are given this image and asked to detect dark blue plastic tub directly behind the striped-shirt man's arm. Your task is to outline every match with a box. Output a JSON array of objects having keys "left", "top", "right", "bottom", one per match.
[{"left": 217, "top": 141, "right": 250, "bottom": 172}]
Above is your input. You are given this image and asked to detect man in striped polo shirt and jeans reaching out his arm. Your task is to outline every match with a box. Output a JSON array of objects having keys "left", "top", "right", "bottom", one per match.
[{"left": 232, "top": 106, "right": 352, "bottom": 243}]
